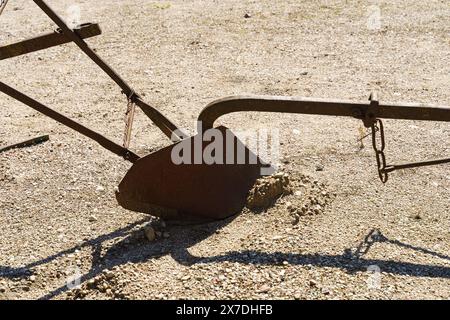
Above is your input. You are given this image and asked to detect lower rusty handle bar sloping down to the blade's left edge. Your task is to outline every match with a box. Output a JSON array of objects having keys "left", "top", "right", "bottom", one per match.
[{"left": 0, "top": 81, "right": 139, "bottom": 163}]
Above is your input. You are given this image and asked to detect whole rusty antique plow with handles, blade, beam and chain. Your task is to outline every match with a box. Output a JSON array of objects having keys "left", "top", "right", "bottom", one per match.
[{"left": 0, "top": 0, "right": 450, "bottom": 223}]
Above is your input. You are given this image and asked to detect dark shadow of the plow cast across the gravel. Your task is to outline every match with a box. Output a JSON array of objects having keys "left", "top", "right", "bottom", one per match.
[{"left": 0, "top": 219, "right": 450, "bottom": 299}]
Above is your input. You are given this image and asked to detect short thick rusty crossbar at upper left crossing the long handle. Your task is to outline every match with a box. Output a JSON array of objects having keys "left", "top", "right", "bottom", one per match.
[{"left": 0, "top": 23, "right": 102, "bottom": 60}]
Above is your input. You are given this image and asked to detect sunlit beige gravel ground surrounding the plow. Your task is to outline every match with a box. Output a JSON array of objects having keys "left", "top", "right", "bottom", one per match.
[{"left": 0, "top": 0, "right": 450, "bottom": 299}]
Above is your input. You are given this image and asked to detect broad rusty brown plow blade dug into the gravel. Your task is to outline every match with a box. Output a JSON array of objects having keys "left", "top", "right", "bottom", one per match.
[{"left": 116, "top": 127, "right": 271, "bottom": 223}]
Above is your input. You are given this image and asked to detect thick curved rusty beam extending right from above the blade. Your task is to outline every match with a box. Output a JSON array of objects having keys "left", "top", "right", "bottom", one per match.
[{"left": 198, "top": 96, "right": 450, "bottom": 129}]
